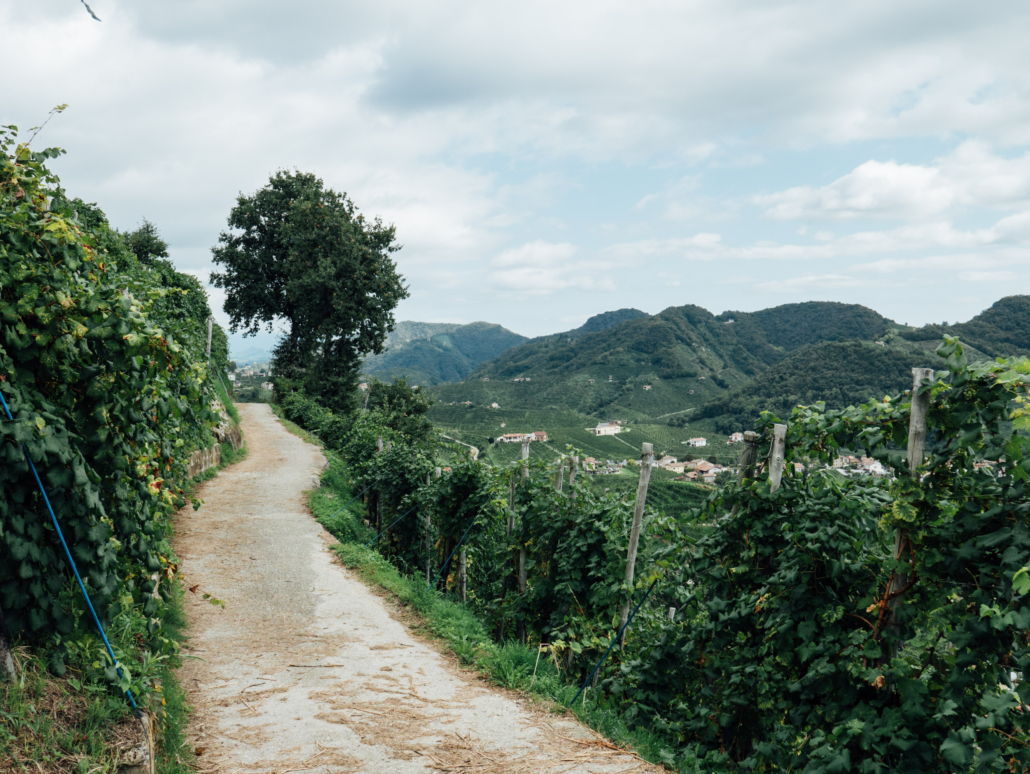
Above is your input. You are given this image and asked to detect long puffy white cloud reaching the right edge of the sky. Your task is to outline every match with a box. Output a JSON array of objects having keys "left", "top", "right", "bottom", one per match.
[{"left": 754, "top": 140, "right": 1030, "bottom": 221}]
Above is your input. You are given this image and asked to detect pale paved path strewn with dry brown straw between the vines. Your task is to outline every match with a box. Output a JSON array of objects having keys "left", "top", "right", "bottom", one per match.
[{"left": 176, "top": 404, "right": 659, "bottom": 774}]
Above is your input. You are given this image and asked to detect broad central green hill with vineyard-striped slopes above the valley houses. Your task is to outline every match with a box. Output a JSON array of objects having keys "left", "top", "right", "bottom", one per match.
[{"left": 434, "top": 302, "right": 890, "bottom": 419}]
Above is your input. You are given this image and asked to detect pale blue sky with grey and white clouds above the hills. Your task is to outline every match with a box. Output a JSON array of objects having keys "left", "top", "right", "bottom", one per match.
[{"left": 0, "top": 0, "right": 1030, "bottom": 351}]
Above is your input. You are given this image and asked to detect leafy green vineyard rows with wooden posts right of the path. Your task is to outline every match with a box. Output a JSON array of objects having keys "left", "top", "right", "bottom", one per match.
[{"left": 281, "top": 339, "right": 1030, "bottom": 774}]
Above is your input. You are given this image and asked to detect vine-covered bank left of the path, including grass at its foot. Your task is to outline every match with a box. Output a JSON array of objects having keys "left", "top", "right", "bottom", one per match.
[{"left": 0, "top": 127, "right": 238, "bottom": 770}]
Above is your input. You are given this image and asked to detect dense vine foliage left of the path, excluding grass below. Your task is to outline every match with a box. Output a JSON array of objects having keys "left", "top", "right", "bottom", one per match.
[{"left": 0, "top": 127, "right": 225, "bottom": 679}]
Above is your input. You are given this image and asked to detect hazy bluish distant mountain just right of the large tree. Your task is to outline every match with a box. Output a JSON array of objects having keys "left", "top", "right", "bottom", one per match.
[{"left": 362, "top": 322, "right": 527, "bottom": 385}]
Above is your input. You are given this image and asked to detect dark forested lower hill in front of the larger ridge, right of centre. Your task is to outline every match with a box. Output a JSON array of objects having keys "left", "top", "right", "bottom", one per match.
[{"left": 691, "top": 341, "right": 941, "bottom": 433}]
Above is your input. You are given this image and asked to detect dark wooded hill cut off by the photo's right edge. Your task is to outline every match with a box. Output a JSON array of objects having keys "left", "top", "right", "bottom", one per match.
[{"left": 898, "top": 296, "right": 1030, "bottom": 358}]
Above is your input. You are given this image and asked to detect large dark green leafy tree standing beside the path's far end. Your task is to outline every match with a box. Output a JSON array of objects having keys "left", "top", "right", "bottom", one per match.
[{"left": 211, "top": 171, "right": 408, "bottom": 410}]
